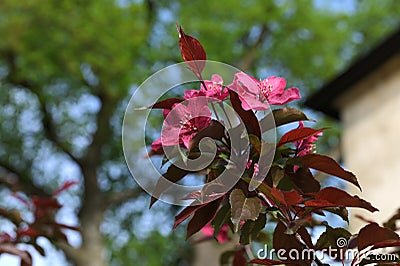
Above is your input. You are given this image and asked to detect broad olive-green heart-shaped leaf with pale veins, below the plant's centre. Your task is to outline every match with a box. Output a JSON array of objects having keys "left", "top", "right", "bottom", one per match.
[{"left": 229, "top": 189, "right": 262, "bottom": 232}]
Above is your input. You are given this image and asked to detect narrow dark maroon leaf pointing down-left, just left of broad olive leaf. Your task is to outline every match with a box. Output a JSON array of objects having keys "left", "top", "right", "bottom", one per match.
[{"left": 186, "top": 198, "right": 222, "bottom": 239}]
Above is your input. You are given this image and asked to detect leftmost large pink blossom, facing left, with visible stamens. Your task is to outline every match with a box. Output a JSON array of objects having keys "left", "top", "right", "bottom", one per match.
[{"left": 160, "top": 97, "right": 212, "bottom": 148}]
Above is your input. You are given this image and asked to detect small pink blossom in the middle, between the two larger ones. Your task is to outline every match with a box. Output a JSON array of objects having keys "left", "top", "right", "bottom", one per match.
[{"left": 183, "top": 74, "right": 229, "bottom": 101}]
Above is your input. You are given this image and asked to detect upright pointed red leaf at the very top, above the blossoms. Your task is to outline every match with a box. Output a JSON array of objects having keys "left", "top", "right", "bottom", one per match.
[{"left": 176, "top": 25, "right": 207, "bottom": 79}]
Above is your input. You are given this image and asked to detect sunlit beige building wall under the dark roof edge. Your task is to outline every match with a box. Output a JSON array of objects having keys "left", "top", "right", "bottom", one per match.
[{"left": 337, "top": 54, "right": 400, "bottom": 232}]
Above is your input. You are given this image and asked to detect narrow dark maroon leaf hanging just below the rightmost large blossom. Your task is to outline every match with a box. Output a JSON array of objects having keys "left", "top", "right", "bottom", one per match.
[{"left": 229, "top": 90, "right": 261, "bottom": 139}]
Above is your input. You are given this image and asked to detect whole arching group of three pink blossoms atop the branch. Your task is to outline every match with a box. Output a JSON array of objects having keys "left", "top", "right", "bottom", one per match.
[{"left": 151, "top": 72, "right": 300, "bottom": 151}]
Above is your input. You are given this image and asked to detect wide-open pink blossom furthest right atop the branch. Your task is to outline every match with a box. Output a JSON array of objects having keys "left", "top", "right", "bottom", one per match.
[{"left": 229, "top": 72, "right": 300, "bottom": 110}]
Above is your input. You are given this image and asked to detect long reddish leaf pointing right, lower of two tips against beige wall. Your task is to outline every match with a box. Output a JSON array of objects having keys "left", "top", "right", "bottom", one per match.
[{"left": 305, "top": 187, "right": 378, "bottom": 212}]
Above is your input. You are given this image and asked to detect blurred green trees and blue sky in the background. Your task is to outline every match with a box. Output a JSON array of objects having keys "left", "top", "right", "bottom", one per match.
[{"left": 0, "top": 0, "right": 400, "bottom": 266}]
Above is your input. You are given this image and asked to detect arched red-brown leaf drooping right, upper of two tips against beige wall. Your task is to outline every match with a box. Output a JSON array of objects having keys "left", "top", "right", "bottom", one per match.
[{"left": 294, "top": 153, "right": 361, "bottom": 190}]
